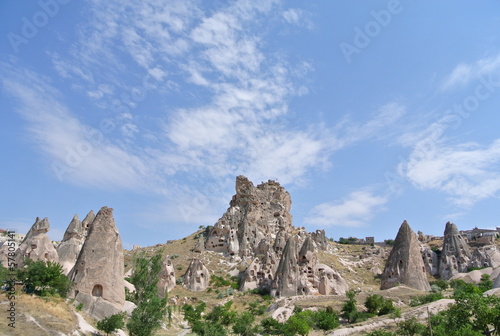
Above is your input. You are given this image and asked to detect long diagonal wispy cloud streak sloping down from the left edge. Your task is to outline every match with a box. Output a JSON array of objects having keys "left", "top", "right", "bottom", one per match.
[{"left": 0, "top": 63, "right": 149, "bottom": 188}]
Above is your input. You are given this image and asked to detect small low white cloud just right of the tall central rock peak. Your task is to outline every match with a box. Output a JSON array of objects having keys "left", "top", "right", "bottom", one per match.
[{"left": 306, "top": 190, "right": 388, "bottom": 227}]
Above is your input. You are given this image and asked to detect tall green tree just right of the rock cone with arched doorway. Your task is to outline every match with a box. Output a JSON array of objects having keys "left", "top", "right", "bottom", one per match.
[{"left": 127, "top": 254, "right": 167, "bottom": 336}]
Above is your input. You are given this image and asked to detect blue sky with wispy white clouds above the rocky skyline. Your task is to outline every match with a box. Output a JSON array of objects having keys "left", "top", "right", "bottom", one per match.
[{"left": 0, "top": 0, "right": 500, "bottom": 248}]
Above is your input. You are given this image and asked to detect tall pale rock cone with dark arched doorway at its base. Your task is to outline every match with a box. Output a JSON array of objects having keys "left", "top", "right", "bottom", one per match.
[{"left": 68, "top": 207, "right": 125, "bottom": 319}]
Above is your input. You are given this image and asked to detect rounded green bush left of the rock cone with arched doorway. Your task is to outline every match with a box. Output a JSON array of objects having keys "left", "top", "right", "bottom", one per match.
[{"left": 17, "top": 259, "right": 72, "bottom": 297}]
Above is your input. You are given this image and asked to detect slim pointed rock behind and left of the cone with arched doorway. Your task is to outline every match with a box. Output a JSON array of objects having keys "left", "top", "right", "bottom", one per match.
[{"left": 57, "top": 214, "right": 86, "bottom": 274}]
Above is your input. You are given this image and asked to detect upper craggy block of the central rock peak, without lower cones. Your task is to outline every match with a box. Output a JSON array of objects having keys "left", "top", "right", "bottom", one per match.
[{"left": 205, "top": 176, "right": 292, "bottom": 257}]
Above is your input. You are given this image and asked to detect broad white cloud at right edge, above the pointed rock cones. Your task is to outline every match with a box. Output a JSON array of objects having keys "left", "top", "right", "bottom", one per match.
[{"left": 399, "top": 123, "right": 500, "bottom": 207}]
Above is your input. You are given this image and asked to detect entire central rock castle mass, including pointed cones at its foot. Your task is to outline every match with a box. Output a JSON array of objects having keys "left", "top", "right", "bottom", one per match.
[{"left": 201, "top": 176, "right": 348, "bottom": 296}]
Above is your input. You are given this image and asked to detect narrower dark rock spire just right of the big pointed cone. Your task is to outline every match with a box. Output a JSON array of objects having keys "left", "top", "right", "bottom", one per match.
[{"left": 439, "top": 222, "right": 472, "bottom": 280}]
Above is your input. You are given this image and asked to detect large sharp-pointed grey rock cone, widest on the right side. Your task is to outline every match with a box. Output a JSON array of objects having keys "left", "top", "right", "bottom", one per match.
[{"left": 380, "top": 221, "right": 431, "bottom": 291}]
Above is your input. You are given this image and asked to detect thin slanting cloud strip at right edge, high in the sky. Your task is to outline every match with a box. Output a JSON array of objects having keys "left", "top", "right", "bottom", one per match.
[{"left": 440, "top": 54, "right": 500, "bottom": 91}]
